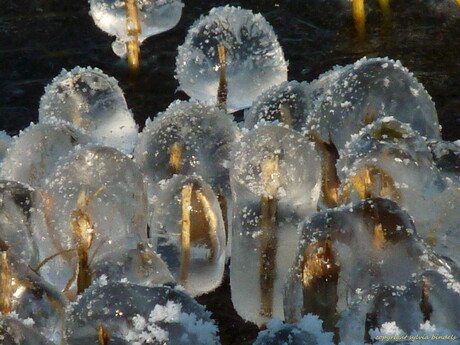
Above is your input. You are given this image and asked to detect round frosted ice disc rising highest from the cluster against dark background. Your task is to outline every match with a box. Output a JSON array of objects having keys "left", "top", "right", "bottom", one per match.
[{"left": 176, "top": 6, "right": 288, "bottom": 112}]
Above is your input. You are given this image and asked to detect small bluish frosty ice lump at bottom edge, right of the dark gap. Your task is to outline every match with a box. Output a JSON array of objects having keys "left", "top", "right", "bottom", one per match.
[{"left": 254, "top": 314, "right": 334, "bottom": 345}]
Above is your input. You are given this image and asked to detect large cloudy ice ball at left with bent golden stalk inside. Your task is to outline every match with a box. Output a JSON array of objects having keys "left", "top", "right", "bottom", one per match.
[{"left": 34, "top": 145, "right": 147, "bottom": 291}]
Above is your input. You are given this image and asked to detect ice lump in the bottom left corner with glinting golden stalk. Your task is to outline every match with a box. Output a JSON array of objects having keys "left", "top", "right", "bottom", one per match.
[{"left": 0, "top": 244, "right": 66, "bottom": 345}]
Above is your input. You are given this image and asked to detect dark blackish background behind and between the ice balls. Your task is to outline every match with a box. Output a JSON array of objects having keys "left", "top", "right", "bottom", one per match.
[{"left": 0, "top": 0, "right": 460, "bottom": 344}]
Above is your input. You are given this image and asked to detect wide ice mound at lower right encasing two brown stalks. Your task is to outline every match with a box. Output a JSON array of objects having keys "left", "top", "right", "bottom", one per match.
[{"left": 285, "top": 199, "right": 454, "bottom": 334}]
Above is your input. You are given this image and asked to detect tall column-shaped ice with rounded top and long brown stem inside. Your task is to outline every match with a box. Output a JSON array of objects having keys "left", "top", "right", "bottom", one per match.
[{"left": 230, "top": 125, "right": 321, "bottom": 325}]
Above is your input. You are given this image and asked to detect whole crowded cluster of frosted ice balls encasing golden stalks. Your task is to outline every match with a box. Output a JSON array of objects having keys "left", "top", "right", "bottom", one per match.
[{"left": 0, "top": 1, "right": 460, "bottom": 345}]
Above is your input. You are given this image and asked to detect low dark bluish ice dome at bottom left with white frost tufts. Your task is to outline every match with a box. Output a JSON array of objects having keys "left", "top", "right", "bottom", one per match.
[{"left": 66, "top": 283, "right": 219, "bottom": 345}]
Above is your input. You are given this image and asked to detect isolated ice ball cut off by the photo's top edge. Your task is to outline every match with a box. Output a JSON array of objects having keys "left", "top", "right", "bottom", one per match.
[{"left": 89, "top": 0, "right": 184, "bottom": 57}]
